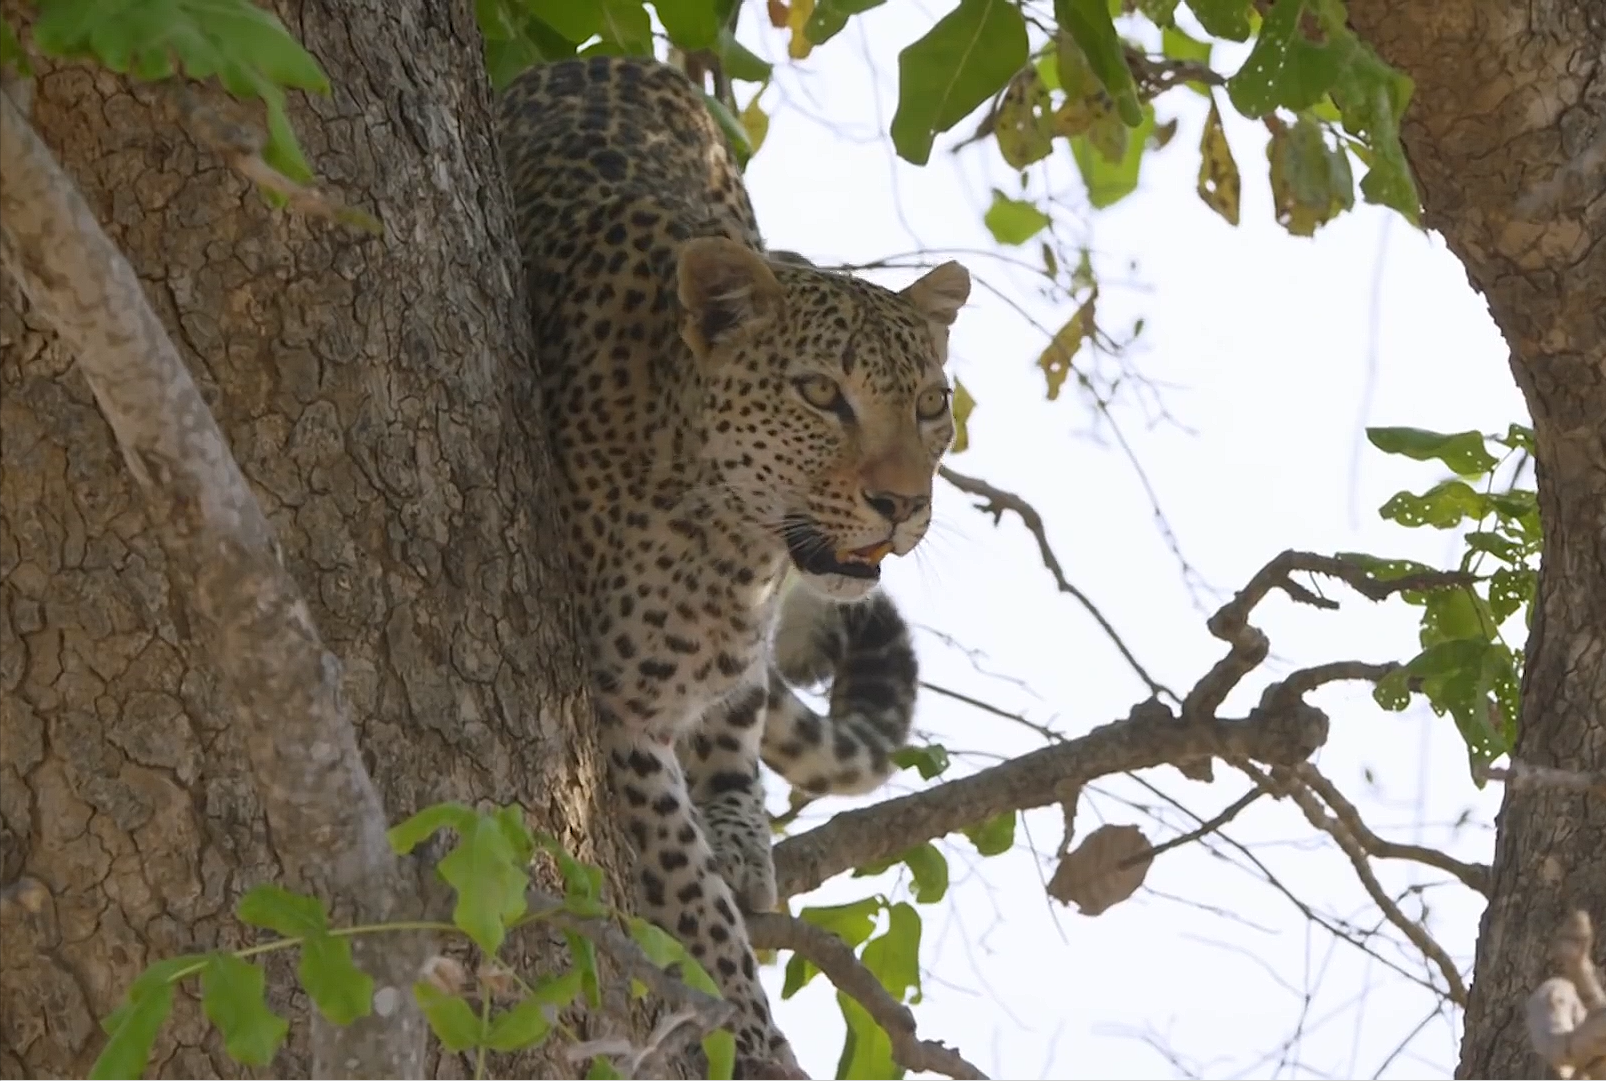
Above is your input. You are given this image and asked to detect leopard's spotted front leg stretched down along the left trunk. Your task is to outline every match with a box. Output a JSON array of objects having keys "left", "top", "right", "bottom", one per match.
[{"left": 602, "top": 707, "right": 797, "bottom": 1070}]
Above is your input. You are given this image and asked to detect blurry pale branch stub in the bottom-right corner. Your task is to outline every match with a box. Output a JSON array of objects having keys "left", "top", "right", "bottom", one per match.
[{"left": 1527, "top": 911, "right": 1606, "bottom": 1081}]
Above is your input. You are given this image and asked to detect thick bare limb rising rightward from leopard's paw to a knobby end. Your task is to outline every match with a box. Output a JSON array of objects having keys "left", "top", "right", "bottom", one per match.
[{"left": 774, "top": 699, "right": 1327, "bottom": 896}]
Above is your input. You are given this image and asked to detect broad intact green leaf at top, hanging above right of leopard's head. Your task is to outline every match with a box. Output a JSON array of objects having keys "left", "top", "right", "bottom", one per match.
[{"left": 891, "top": 0, "right": 1026, "bottom": 165}]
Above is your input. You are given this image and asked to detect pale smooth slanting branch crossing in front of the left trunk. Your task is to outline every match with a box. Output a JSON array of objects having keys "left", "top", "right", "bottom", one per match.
[{"left": 0, "top": 93, "right": 427, "bottom": 1078}]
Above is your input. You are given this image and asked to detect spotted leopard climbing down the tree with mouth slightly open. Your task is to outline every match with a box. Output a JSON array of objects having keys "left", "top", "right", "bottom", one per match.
[{"left": 496, "top": 55, "right": 970, "bottom": 1071}]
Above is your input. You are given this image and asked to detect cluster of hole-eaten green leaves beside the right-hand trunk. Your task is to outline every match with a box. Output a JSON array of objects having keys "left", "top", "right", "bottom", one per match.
[{"left": 1346, "top": 424, "right": 1542, "bottom": 779}]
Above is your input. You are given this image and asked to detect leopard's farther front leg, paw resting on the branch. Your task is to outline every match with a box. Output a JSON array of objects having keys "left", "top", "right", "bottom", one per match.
[{"left": 678, "top": 686, "right": 777, "bottom": 912}]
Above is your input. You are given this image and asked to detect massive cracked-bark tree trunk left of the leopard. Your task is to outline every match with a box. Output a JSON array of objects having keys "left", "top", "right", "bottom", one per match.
[{"left": 0, "top": 0, "right": 639, "bottom": 1078}]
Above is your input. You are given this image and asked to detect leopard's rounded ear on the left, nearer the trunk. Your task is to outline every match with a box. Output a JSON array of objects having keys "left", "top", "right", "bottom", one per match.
[{"left": 676, "top": 236, "right": 785, "bottom": 357}]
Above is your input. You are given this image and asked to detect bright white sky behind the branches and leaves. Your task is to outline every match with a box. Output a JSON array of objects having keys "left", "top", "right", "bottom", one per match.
[{"left": 725, "top": 2, "right": 1526, "bottom": 1078}]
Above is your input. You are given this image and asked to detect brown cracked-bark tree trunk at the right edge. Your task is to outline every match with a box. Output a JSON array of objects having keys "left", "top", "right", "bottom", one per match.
[{"left": 1349, "top": 0, "right": 1606, "bottom": 1078}]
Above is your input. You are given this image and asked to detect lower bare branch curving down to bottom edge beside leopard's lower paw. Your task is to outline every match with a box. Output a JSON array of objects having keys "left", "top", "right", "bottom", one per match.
[{"left": 747, "top": 912, "right": 988, "bottom": 1081}]
